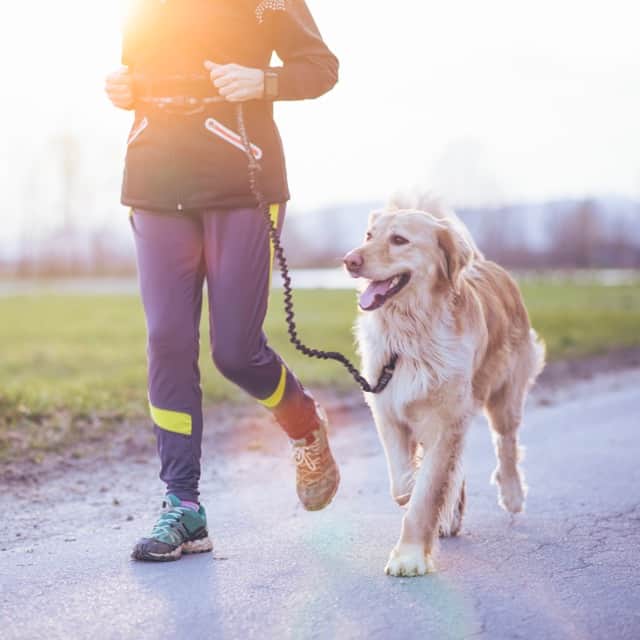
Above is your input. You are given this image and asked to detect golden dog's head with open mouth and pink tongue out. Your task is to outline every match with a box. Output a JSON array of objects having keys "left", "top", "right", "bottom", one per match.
[{"left": 344, "top": 209, "right": 473, "bottom": 311}]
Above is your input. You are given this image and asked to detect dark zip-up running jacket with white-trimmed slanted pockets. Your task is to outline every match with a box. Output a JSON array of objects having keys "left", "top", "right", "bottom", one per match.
[{"left": 122, "top": 0, "right": 338, "bottom": 212}]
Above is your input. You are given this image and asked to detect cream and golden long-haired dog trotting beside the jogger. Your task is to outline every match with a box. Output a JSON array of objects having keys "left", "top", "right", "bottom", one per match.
[{"left": 344, "top": 198, "right": 545, "bottom": 576}]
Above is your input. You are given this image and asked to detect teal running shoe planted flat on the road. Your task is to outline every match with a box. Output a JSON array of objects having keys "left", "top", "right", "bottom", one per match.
[{"left": 131, "top": 493, "right": 213, "bottom": 562}]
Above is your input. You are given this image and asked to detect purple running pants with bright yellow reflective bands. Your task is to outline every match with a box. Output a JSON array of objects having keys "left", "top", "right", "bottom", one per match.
[{"left": 131, "top": 205, "right": 315, "bottom": 501}]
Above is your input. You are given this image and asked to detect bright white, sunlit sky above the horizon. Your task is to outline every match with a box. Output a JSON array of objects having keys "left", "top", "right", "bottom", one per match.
[{"left": 0, "top": 0, "right": 640, "bottom": 245}]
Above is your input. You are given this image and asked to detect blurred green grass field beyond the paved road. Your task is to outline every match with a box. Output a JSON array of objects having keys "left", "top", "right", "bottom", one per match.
[{"left": 0, "top": 280, "right": 640, "bottom": 457}]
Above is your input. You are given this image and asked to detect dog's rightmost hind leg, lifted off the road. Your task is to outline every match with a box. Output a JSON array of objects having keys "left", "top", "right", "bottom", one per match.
[{"left": 485, "top": 380, "right": 527, "bottom": 513}]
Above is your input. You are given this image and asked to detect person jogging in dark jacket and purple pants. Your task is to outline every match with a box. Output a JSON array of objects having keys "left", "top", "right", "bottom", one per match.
[{"left": 106, "top": 0, "right": 340, "bottom": 560}]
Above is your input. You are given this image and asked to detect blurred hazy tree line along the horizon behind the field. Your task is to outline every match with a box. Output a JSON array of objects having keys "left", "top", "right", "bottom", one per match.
[{"left": 0, "top": 200, "right": 640, "bottom": 277}]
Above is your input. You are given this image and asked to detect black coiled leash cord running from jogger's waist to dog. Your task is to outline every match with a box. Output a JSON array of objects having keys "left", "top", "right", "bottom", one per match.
[{"left": 236, "top": 103, "right": 398, "bottom": 393}]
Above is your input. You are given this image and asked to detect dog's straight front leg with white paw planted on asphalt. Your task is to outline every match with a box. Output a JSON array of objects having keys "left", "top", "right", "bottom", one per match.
[{"left": 385, "top": 421, "right": 466, "bottom": 576}]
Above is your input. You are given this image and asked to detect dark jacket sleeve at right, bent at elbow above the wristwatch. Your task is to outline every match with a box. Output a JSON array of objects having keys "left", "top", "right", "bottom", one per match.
[{"left": 269, "top": 0, "right": 338, "bottom": 100}]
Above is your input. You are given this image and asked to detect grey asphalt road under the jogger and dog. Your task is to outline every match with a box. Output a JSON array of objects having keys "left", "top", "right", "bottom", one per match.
[{"left": 0, "top": 371, "right": 640, "bottom": 640}]
